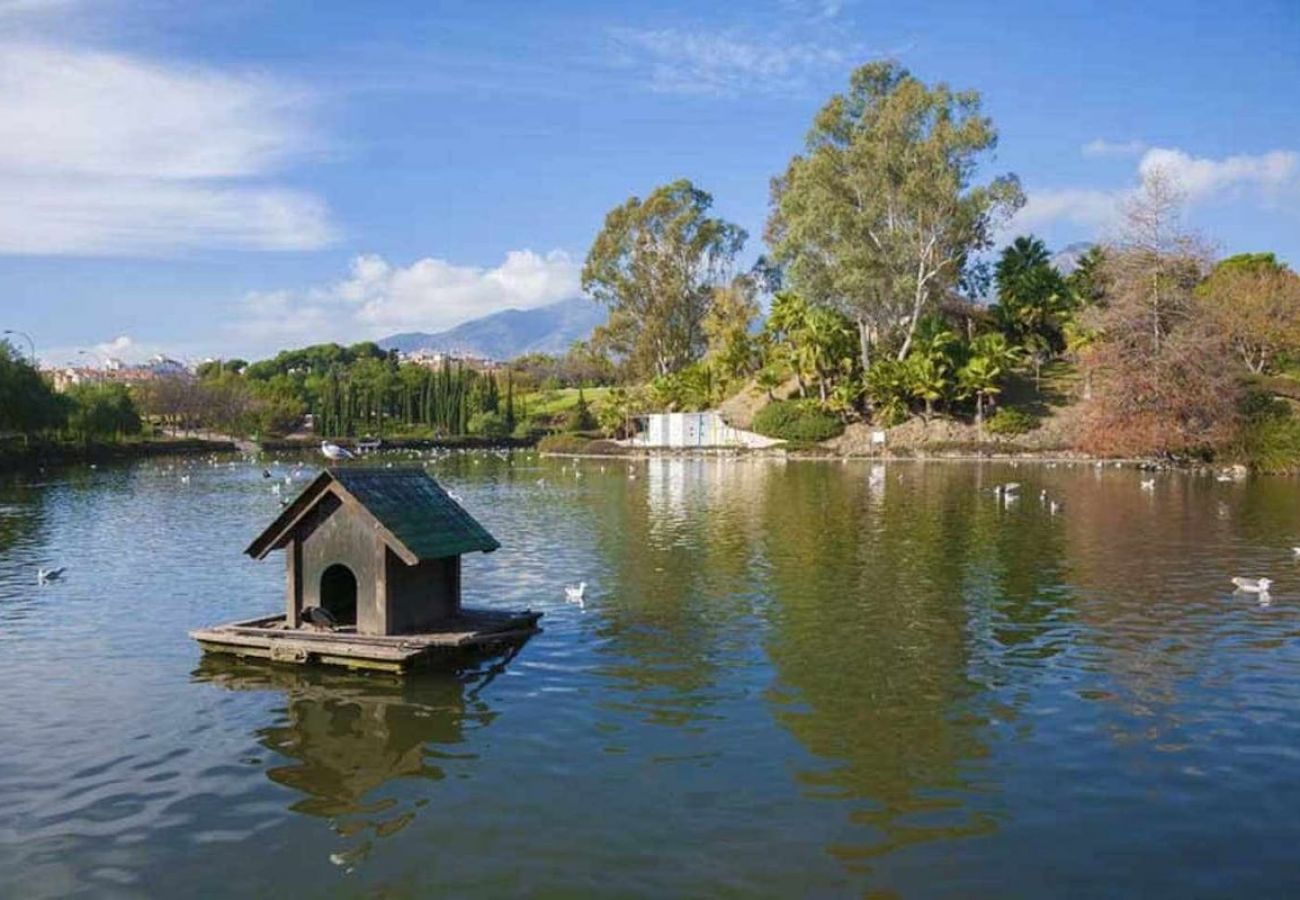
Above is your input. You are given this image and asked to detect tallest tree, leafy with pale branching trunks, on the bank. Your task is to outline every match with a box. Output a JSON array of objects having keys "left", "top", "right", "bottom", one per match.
[{"left": 767, "top": 62, "right": 1024, "bottom": 369}]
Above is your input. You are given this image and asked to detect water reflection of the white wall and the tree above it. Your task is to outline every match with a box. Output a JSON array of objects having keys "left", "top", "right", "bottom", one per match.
[{"left": 589, "top": 459, "right": 770, "bottom": 726}]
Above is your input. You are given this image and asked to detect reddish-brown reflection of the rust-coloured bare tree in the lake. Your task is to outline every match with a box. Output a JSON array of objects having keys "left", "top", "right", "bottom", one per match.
[{"left": 1045, "top": 471, "right": 1279, "bottom": 745}]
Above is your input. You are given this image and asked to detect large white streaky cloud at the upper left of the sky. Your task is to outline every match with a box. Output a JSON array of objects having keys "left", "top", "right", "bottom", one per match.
[{"left": 0, "top": 43, "right": 334, "bottom": 255}]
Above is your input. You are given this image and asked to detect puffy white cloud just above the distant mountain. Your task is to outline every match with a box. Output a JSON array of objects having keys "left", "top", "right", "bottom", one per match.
[{"left": 234, "top": 250, "right": 581, "bottom": 350}]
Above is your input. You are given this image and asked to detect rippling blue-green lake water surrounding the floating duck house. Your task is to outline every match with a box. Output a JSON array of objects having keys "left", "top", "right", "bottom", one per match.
[{"left": 0, "top": 455, "right": 1300, "bottom": 897}]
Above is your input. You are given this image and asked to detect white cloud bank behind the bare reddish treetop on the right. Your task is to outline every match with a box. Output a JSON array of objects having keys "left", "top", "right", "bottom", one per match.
[{"left": 1008, "top": 142, "right": 1300, "bottom": 233}]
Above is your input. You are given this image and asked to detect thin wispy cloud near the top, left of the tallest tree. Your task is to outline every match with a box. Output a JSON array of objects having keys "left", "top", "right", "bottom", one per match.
[{"left": 611, "top": 29, "right": 857, "bottom": 95}]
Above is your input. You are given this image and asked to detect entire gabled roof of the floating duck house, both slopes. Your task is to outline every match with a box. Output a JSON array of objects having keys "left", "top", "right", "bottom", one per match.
[{"left": 247, "top": 466, "right": 501, "bottom": 562}]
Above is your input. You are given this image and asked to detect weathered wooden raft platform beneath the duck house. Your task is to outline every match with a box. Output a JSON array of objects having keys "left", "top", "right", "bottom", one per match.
[{"left": 190, "top": 609, "right": 542, "bottom": 672}]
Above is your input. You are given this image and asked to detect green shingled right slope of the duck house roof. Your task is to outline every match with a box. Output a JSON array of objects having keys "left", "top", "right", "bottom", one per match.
[{"left": 329, "top": 467, "right": 501, "bottom": 559}]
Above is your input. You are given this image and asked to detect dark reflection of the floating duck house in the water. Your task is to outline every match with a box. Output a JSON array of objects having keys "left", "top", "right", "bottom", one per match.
[{"left": 195, "top": 655, "right": 495, "bottom": 865}]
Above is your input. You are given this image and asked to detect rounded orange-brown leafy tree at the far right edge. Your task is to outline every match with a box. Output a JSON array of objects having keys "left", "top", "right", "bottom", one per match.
[{"left": 1196, "top": 254, "right": 1300, "bottom": 375}]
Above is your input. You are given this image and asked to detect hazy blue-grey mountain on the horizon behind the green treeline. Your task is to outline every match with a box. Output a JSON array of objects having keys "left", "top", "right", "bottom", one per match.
[{"left": 378, "top": 297, "right": 605, "bottom": 360}]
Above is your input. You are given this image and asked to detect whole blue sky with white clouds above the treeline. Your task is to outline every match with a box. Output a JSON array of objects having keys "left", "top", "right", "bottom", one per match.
[{"left": 0, "top": 0, "right": 1300, "bottom": 362}]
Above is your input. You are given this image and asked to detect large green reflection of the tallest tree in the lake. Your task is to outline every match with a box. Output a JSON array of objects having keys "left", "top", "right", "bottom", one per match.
[{"left": 763, "top": 466, "right": 1076, "bottom": 867}]
